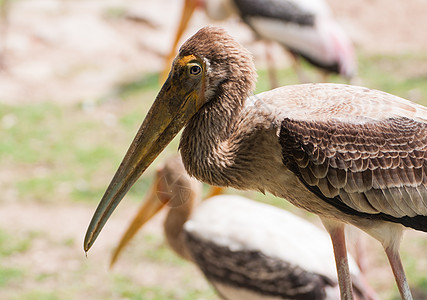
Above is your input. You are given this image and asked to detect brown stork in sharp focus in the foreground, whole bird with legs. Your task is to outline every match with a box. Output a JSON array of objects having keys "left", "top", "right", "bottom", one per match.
[{"left": 84, "top": 26, "right": 427, "bottom": 300}]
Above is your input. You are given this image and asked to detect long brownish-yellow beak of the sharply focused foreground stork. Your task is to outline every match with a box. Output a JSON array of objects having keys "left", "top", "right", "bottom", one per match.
[{"left": 84, "top": 76, "right": 200, "bottom": 252}]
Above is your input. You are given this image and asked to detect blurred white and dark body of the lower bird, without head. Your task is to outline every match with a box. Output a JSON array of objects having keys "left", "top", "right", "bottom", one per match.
[{"left": 184, "top": 195, "right": 358, "bottom": 299}]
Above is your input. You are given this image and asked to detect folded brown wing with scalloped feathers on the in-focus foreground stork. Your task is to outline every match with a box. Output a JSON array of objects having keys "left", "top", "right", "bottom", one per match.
[{"left": 280, "top": 117, "right": 427, "bottom": 230}]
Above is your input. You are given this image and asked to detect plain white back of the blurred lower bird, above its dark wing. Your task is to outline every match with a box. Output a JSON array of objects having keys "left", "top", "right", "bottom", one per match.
[{"left": 188, "top": 195, "right": 359, "bottom": 281}]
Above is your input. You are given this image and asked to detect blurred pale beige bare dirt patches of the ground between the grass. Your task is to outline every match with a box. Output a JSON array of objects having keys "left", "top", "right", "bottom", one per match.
[{"left": 0, "top": 0, "right": 427, "bottom": 299}]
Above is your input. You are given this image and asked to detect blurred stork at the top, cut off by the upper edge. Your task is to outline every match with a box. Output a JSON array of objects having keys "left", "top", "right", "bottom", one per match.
[{"left": 163, "top": 0, "right": 357, "bottom": 87}]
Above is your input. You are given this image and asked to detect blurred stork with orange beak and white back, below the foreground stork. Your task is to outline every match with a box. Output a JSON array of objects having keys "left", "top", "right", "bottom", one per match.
[{"left": 110, "top": 155, "right": 376, "bottom": 300}]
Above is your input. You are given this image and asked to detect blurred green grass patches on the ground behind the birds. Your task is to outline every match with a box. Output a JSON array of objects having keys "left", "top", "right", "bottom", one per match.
[{"left": 0, "top": 54, "right": 427, "bottom": 300}]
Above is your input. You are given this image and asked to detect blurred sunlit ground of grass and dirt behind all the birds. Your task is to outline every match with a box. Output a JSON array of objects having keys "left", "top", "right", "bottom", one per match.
[{"left": 0, "top": 0, "right": 427, "bottom": 300}]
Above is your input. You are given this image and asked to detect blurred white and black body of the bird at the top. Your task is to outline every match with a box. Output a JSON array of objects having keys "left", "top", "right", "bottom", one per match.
[{"left": 233, "top": 0, "right": 357, "bottom": 78}]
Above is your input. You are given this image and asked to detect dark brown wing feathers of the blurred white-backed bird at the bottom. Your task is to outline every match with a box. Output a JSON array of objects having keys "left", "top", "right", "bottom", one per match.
[{"left": 185, "top": 232, "right": 336, "bottom": 299}]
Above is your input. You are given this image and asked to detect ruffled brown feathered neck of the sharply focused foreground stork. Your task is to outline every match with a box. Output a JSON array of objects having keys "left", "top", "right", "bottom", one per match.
[{"left": 180, "top": 81, "right": 248, "bottom": 186}]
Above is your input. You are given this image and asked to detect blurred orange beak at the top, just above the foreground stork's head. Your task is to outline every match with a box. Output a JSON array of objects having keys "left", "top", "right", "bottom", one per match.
[{"left": 160, "top": 0, "right": 197, "bottom": 82}]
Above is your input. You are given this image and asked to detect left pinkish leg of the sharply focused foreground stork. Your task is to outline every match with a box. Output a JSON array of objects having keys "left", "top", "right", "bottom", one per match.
[{"left": 321, "top": 218, "right": 353, "bottom": 300}]
